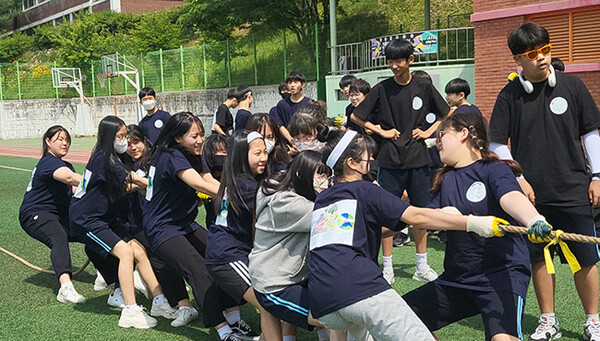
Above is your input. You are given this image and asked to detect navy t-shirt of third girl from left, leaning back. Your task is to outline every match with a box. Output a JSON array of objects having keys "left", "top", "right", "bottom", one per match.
[{"left": 142, "top": 149, "right": 210, "bottom": 250}]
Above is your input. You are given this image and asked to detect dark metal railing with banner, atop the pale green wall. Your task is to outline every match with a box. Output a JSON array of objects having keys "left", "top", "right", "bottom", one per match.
[{"left": 331, "top": 27, "right": 475, "bottom": 74}]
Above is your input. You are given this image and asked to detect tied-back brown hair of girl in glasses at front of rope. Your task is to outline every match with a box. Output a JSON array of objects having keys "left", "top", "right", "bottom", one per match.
[{"left": 430, "top": 112, "right": 523, "bottom": 193}]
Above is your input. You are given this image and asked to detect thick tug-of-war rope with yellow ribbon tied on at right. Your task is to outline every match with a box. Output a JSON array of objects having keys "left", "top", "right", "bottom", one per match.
[{"left": 500, "top": 225, "right": 600, "bottom": 274}]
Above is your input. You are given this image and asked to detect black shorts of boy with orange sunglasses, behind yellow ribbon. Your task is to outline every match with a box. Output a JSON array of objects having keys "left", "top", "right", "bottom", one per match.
[{"left": 527, "top": 205, "right": 600, "bottom": 268}]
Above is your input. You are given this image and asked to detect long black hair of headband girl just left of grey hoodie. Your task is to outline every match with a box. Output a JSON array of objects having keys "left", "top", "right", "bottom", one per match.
[{"left": 214, "top": 129, "right": 264, "bottom": 214}]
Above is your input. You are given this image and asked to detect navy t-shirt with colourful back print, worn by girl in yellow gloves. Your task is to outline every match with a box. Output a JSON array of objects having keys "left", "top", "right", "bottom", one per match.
[{"left": 308, "top": 180, "right": 409, "bottom": 318}]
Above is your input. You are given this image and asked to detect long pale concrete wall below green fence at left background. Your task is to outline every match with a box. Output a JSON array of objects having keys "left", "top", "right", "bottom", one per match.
[{"left": 0, "top": 82, "right": 317, "bottom": 139}]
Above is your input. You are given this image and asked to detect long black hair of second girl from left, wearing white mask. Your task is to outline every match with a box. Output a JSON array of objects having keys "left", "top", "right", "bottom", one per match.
[{"left": 90, "top": 116, "right": 131, "bottom": 203}]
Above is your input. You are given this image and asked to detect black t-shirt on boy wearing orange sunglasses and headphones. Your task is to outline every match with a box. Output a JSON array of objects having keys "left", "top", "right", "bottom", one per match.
[{"left": 490, "top": 72, "right": 600, "bottom": 206}]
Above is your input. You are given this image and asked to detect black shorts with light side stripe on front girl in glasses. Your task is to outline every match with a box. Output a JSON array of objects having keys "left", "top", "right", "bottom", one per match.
[{"left": 402, "top": 281, "right": 525, "bottom": 340}]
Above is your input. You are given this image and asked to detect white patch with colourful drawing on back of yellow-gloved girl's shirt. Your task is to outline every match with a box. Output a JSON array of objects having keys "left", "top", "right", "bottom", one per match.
[{"left": 310, "top": 200, "right": 356, "bottom": 250}]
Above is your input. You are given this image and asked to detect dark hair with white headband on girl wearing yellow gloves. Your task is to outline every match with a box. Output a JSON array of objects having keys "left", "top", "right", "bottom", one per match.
[{"left": 321, "top": 129, "right": 376, "bottom": 176}]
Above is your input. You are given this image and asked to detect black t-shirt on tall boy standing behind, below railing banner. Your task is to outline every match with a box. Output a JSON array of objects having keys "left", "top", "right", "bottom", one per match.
[{"left": 352, "top": 77, "right": 450, "bottom": 169}]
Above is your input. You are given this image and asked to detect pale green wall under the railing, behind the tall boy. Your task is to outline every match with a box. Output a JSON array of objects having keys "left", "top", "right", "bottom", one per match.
[{"left": 325, "top": 64, "right": 475, "bottom": 117}]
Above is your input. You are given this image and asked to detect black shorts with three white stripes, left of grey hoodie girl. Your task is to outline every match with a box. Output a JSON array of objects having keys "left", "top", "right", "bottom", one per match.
[{"left": 207, "top": 259, "right": 252, "bottom": 304}]
